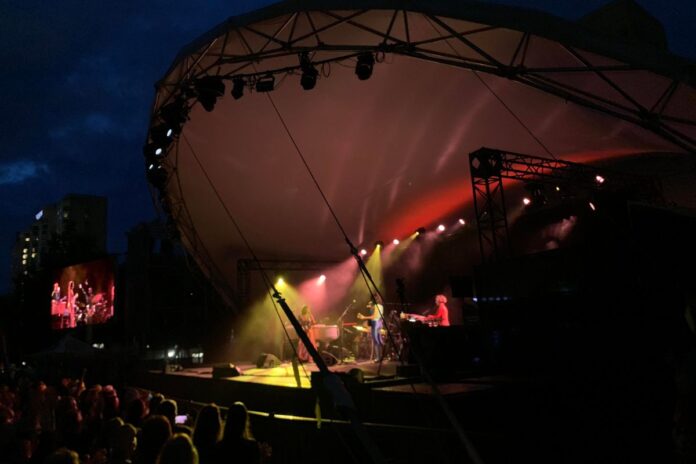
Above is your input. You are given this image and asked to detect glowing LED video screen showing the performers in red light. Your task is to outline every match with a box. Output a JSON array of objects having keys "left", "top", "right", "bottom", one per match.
[{"left": 50, "top": 258, "right": 115, "bottom": 330}]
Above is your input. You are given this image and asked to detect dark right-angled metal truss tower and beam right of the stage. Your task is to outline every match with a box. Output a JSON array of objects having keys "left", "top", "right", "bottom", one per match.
[{"left": 469, "top": 147, "right": 662, "bottom": 262}]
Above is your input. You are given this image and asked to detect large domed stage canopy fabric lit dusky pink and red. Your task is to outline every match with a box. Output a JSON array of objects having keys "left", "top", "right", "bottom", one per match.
[{"left": 147, "top": 0, "right": 696, "bottom": 306}]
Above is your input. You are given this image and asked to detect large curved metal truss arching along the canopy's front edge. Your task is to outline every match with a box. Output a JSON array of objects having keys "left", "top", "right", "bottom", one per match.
[{"left": 159, "top": 10, "right": 696, "bottom": 153}]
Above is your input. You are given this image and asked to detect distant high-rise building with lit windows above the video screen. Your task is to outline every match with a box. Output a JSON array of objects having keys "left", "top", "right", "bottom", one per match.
[{"left": 12, "top": 194, "right": 107, "bottom": 277}]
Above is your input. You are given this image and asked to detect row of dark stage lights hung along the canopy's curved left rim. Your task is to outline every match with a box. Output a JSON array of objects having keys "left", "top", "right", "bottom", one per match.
[{"left": 143, "top": 52, "right": 375, "bottom": 189}]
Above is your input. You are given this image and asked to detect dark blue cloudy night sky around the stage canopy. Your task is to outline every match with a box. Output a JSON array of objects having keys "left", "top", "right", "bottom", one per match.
[{"left": 0, "top": 0, "right": 696, "bottom": 292}]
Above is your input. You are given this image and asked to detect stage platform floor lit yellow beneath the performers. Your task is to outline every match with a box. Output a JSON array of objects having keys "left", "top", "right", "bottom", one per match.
[{"left": 132, "top": 361, "right": 500, "bottom": 423}]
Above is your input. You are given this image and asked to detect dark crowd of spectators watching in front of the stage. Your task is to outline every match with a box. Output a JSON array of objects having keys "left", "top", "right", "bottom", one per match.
[{"left": 0, "top": 379, "right": 270, "bottom": 464}]
